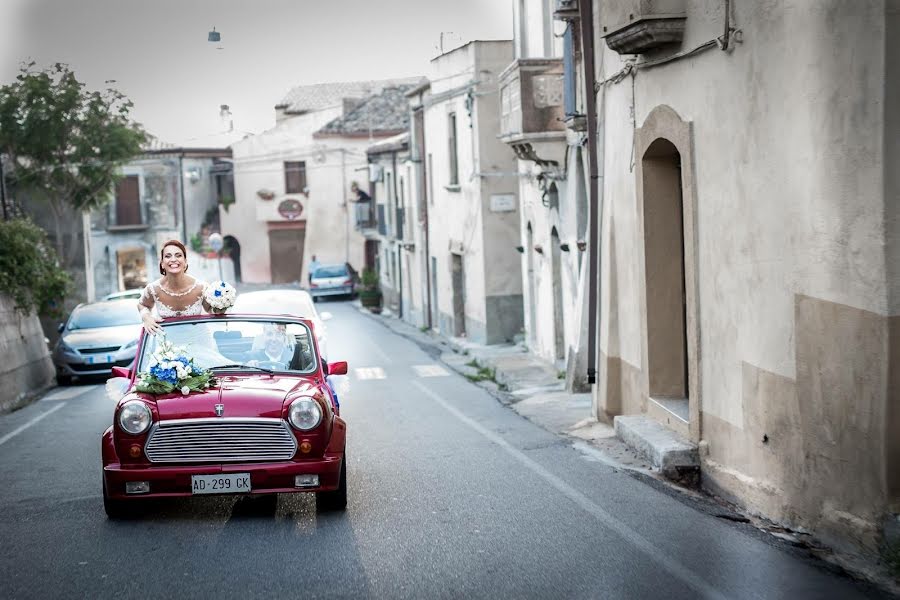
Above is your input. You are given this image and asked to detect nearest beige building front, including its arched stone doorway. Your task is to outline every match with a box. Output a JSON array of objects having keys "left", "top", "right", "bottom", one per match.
[{"left": 584, "top": 0, "right": 900, "bottom": 550}]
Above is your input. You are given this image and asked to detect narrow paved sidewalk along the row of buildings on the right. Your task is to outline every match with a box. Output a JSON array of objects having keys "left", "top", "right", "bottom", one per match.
[{"left": 356, "top": 302, "right": 661, "bottom": 480}]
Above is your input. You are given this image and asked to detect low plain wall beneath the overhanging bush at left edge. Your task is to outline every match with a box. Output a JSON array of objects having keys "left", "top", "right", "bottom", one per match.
[{"left": 0, "top": 295, "right": 55, "bottom": 414}]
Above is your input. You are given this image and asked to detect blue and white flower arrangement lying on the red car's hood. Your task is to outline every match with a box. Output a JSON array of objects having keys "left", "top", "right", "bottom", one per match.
[{"left": 136, "top": 339, "right": 215, "bottom": 396}]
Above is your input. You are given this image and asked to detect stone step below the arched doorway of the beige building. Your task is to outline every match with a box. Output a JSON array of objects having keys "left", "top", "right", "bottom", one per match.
[{"left": 613, "top": 415, "right": 700, "bottom": 486}]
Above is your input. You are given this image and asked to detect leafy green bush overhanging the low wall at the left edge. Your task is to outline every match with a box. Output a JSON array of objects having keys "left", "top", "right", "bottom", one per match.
[{"left": 0, "top": 219, "right": 71, "bottom": 317}]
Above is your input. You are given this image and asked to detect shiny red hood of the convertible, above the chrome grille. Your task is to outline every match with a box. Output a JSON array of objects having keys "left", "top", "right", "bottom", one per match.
[{"left": 144, "top": 375, "right": 316, "bottom": 421}]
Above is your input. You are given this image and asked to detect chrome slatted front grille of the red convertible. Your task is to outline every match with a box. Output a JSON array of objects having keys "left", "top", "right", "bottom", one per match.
[{"left": 144, "top": 418, "right": 297, "bottom": 463}]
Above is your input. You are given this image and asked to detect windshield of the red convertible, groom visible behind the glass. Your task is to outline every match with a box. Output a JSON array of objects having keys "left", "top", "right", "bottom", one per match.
[{"left": 138, "top": 317, "right": 318, "bottom": 373}]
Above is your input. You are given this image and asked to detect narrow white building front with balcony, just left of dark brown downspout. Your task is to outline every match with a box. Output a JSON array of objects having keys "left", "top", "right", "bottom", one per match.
[{"left": 500, "top": 0, "right": 589, "bottom": 391}]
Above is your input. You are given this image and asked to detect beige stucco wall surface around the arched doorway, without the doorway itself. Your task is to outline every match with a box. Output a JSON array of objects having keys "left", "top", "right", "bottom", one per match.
[{"left": 597, "top": 0, "right": 900, "bottom": 548}]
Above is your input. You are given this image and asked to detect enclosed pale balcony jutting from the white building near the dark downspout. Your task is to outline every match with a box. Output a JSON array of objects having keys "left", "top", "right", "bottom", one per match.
[{"left": 499, "top": 58, "right": 566, "bottom": 169}]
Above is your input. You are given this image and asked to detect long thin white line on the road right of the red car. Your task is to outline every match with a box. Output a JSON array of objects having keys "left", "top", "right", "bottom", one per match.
[{"left": 412, "top": 380, "right": 726, "bottom": 600}]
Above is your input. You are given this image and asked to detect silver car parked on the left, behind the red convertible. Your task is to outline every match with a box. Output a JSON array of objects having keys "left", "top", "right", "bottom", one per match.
[{"left": 53, "top": 299, "right": 142, "bottom": 385}]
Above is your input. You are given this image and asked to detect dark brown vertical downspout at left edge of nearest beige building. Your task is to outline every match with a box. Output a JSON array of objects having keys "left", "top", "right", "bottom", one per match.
[{"left": 579, "top": 0, "right": 603, "bottom": 385}]
